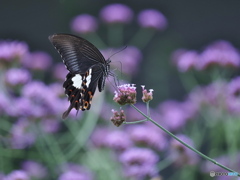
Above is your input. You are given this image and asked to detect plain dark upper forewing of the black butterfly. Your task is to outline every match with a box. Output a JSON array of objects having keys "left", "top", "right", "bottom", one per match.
[{"left": 49, "top": 34, "right": 106, "bottom": 74}]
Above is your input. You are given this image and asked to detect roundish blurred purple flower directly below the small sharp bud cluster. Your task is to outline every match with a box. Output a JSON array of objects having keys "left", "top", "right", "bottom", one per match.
[{"left": 105, "top": 131, "right": 132, "bottom": 151}]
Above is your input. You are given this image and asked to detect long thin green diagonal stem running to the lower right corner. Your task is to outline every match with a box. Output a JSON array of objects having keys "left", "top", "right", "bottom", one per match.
[{"left": 131, "top": 104, "right": 240, "bottom": 177}]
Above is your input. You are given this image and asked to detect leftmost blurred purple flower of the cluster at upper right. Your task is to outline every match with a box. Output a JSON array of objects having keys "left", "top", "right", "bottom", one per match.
[{"left": 173, "top": 50, "right": 201, "bottom": 72}]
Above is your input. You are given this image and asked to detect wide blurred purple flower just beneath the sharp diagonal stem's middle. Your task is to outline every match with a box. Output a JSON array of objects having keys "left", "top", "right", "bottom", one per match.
[{"left": 127, "top": 125, "right": 167, "bottom": 151}]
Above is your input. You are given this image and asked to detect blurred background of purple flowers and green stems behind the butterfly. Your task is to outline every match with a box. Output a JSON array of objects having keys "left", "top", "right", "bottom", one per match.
[{"left": 0, "top": 0, "right": 240, "bottom": 180}]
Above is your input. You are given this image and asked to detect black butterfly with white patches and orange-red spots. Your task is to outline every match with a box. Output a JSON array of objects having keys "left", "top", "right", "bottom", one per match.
[{"left": 49, "top": 34, "right": 111, "bottom": 119}]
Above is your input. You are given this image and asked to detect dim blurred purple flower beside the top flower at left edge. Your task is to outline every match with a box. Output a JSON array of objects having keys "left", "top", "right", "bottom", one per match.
[{"left": 22, "top": 51, "right": 52, "bottom": 70}]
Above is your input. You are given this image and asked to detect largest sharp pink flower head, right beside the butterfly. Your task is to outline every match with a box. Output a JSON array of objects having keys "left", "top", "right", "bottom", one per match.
[{"left": 113, "top": 84, "right": 137, "bottom": 105}]
